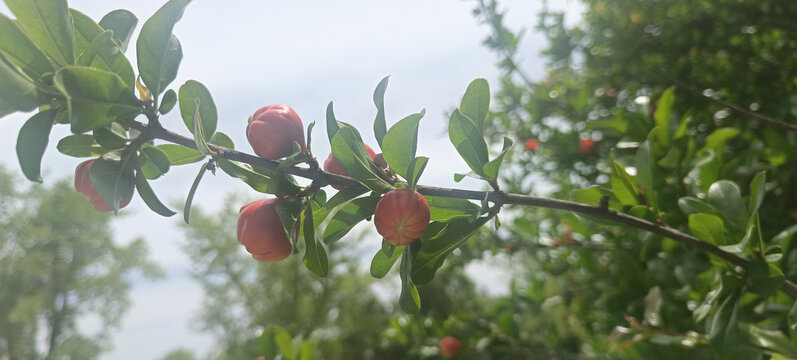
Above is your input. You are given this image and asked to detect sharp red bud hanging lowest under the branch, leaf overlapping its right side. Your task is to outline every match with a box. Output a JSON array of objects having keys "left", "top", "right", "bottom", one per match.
[{"left": 238, "top": 199, "right": 291, "bottom": 262}]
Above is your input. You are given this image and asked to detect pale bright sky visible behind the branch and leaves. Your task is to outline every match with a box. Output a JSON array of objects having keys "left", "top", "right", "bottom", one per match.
[{"left": 0, "top": 0, "right": 577, "bottom": 360}]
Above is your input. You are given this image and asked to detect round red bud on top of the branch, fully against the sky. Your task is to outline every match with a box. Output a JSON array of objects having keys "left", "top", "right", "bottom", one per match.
[{"left": 246, "top": 104, "right": 307, "bottom": 160}]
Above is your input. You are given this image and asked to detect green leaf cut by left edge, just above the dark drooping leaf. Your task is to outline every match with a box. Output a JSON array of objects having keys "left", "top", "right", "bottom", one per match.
[{"left": 0, "top": 53, "right": 48, "bottom": 113}]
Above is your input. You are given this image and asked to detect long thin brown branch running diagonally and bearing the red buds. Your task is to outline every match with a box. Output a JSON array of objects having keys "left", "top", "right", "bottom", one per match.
[{"left": 131, "top": 121, "right": 797, "bottom": 298}]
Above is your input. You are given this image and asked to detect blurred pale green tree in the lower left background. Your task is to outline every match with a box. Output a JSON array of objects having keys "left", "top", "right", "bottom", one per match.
[{"left": 0, "top": 168, "right": 161, "bottom": 360}]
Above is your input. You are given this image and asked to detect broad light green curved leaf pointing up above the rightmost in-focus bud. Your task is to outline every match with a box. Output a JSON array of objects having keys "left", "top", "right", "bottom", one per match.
[{"left": 381, "top": 111, "right": 424, "bottom": 180}]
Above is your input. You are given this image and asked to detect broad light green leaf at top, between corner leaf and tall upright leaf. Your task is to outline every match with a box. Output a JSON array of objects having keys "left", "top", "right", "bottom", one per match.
[{"left": 69, "top": 9, "right": 136, "bottom": 87}]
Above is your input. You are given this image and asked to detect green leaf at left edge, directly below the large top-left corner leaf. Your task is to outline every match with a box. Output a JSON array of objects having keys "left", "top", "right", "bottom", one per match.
[{"left": 0, "top": 14, "right": 54, "bottom": 80}]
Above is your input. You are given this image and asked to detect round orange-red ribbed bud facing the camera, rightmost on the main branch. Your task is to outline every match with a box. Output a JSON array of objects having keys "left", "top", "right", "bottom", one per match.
[{"left": 374, "top": 189, "right": 430, "bottom": 246}]
